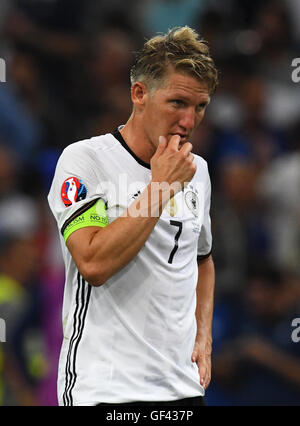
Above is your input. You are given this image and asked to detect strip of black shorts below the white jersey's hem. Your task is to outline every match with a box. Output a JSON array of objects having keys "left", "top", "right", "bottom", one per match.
[{"left": 96, "top": 396, "right": 205, "bottom": 407}]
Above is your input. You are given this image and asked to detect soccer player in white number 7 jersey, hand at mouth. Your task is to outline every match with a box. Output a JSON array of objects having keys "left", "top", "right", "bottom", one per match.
[{"left": 48, "top": 27, "right": 218, "bottom": 405}]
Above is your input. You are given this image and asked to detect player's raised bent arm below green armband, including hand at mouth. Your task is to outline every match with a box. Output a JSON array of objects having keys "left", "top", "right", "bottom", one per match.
[{"left": 67, "top": 136, "right": 196, "bottom": 286}]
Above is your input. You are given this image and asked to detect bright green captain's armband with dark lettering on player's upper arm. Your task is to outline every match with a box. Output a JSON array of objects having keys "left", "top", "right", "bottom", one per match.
[{"left": 63, "top": 200, "right": 109, "bottom": 242}]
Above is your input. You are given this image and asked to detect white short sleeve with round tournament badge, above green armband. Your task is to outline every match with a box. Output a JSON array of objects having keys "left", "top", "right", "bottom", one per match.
[{"left": 48, "top": 141, "right": 107, "bottom": 231}]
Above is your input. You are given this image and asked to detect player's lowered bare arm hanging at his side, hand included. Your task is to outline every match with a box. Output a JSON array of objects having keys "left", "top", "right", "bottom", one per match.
[{"left": 192, "top": 256, "right": 215, "bottom": 389}]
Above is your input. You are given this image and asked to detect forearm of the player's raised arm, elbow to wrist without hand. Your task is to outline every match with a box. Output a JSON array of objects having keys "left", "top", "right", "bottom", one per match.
[{"left": 75, "top": 184, "right": 170, "bottom": 285}]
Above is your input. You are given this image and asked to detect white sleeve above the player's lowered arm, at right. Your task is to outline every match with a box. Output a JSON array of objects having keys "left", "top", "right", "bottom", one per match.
[{"left": 198, "top": 165, "right": 212, "bottom": 260}]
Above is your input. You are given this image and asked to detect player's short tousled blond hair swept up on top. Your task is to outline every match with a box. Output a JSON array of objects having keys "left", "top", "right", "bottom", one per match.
[{"left": 130, "top": 26, "right": 218, "bottom": 94}]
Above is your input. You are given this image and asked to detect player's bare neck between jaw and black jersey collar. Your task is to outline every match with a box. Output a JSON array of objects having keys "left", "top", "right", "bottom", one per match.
[{"left": 120, "top": 112, "right": 156, "bottom": 164}]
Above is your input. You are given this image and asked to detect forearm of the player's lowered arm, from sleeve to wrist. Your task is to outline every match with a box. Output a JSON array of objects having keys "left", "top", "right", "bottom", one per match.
[{"left": 196, "top": 256, "right": 215, "bottom": 351}]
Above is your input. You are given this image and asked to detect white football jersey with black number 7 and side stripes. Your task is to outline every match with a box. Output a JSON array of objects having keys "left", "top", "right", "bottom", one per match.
[{"left": 48, "top": 132, "right": 212, "bottom": 405}]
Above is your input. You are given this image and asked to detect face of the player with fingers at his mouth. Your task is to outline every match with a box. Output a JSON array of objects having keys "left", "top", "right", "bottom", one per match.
[{"left": 139, "top": 71, "right": 210, "bottom": 148}]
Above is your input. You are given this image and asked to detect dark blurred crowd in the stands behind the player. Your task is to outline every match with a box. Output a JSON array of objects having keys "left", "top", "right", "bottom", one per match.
[{"left": 0, "top": 0, "right": 300, "bottom": 405}]
